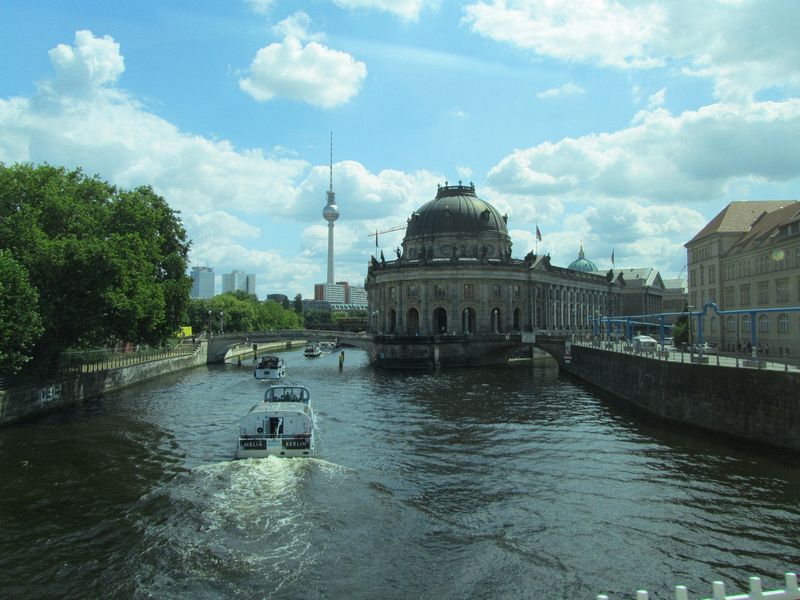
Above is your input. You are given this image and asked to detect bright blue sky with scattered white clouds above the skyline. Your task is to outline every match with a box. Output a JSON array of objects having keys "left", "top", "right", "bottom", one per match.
[{"left": 0, "top": 0, "right": 800, "bottom": 299}]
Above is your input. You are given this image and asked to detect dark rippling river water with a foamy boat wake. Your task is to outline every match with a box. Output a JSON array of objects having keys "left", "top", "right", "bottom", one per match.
[{"left": 0, "top": 350, "right": 800, "bottom": 600}]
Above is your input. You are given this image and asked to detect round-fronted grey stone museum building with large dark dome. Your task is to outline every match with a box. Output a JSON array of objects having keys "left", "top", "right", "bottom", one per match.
[{"left": 365, "top": 182, "right": 628, "bottom": 368}]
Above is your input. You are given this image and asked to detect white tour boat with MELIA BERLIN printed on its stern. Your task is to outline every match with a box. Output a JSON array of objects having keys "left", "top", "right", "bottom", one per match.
[{"left": 236, "top": 385, "right": 314, "bottom": 458}]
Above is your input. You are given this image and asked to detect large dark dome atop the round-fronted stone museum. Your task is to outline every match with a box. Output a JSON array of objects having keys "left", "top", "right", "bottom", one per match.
[{"left": 406, "top": 182, "right": 508, "bottom": 240}]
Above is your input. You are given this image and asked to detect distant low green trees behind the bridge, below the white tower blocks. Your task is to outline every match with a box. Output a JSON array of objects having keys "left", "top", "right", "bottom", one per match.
[{"left": 187, "top": 291, "right": 303, "bottom": 333}]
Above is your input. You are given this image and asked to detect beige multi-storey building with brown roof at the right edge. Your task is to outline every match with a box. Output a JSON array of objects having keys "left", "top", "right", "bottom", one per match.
[{"left": 686, "top": 200, "right": 800, "bottom": 357}]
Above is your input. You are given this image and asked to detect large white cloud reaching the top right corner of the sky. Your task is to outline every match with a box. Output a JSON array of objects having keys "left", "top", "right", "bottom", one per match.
[{"left": 464, "top": 0, "right": 800, "bottom": 101}]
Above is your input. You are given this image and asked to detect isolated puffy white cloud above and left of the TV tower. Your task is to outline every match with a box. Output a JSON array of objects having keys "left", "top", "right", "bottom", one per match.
[{"left": 239, "top": 37, "right": 367, "bottom": 108}]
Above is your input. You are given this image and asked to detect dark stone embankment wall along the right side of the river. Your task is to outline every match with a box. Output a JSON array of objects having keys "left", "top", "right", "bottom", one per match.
[{"left": 539, "top": 342, "right": 800, "bottom": 451}]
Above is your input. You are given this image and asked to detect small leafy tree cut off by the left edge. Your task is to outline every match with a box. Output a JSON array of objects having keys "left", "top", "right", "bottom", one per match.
[{"left": 0, "top": 250, "right": 43, "bottom": 373}]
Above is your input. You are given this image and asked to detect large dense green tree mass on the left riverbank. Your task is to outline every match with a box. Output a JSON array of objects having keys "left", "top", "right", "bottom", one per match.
[{"left": 0, "top": 164, "right": 191, "bottom": 368}]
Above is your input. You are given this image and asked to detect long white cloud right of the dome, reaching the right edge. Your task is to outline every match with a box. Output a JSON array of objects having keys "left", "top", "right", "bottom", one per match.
[{"left": 488, "top": 100, "right": 800, "bottom": 202}]
